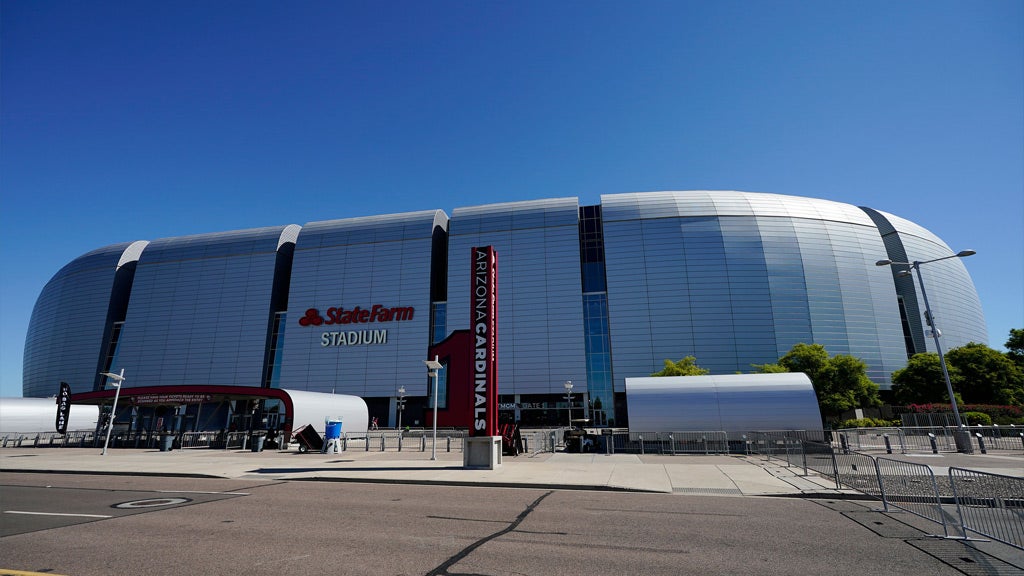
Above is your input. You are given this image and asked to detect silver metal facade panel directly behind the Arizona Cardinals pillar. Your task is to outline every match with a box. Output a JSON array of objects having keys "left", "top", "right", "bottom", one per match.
[{"left": 447, "top": 198, "right": 587, "bottom": 396}]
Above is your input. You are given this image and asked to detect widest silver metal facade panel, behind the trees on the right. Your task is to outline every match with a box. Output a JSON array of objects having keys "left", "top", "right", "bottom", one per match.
[{"left": 601, "top": 192, "right": 905, "bottom": 389}]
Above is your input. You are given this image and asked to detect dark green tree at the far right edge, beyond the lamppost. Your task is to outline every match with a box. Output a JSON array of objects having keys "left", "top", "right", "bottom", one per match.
[{"left": 946, "top": 342, "right": 1024, "bottom": 406}]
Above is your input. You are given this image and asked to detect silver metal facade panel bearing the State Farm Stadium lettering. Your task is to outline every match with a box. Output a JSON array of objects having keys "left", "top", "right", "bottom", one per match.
[{"left": 281, "top": 210, "right": 442, "bottom": 397}]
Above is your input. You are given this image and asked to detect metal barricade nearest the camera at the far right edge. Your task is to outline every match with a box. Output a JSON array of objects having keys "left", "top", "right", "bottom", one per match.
[{"left": 949, "top": 467, "right": 1024, "bottom": 549}]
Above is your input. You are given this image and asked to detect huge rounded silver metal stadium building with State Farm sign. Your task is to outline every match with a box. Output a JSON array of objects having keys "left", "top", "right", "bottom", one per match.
[{"left": 24, "top": 192, "right": 987, "bottom": 429}]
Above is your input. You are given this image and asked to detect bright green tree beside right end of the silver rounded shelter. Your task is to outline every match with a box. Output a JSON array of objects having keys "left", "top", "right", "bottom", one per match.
[{"left": 770, "top": 342, "right": 882, "bottom": 420}]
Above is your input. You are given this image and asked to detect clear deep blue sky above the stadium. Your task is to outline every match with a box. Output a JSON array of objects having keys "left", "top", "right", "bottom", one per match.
[{"left": 0, "top": 0, "right": 1024, "bottom": 396}]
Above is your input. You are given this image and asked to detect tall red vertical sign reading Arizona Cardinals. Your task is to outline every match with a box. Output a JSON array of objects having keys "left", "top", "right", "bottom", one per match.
[{"left": 469, "top": 246, "right": 498, "bottom": 436}]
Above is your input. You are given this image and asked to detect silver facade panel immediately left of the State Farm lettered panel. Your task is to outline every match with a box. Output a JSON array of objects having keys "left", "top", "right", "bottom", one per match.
[{"left": 118, "top": 227, "right": 294, "bottom": 387}]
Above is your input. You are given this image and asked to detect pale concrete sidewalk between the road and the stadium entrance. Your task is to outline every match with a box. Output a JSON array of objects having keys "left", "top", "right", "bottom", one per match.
[{"left": 0, "top": 448, "right": 849, "bottom": 496}]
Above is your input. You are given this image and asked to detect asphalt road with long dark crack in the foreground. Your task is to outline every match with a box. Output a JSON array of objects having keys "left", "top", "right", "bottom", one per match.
[{"left": 0, "top": 472, "right": 1017, "bottom": 576}]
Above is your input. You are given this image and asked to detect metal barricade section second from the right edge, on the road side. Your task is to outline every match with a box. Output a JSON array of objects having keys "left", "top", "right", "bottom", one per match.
[{"left": 874, "top": 458, "right": 949, "bottom": 537}]
